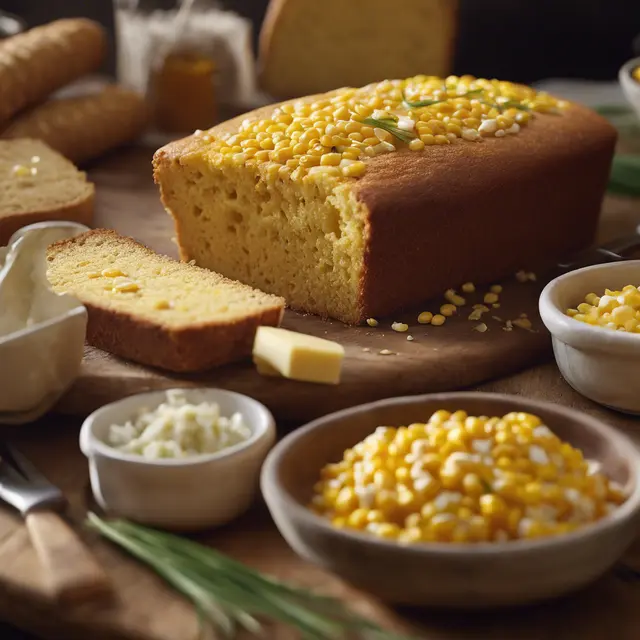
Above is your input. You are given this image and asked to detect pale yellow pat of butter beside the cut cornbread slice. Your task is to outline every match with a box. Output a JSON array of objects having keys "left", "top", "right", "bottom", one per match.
[{"left": 253, "top": 327, "right": 344, "bottom": 384}]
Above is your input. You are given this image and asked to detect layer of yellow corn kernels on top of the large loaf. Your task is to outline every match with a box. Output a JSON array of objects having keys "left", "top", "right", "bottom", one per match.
[{"left": 198, "top": 75, "right": 568, "bottom": 181}]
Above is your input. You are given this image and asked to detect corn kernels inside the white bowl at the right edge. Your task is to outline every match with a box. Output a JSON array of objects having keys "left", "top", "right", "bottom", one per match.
[{"left": 568, "top": 284, "right": 640, "bottom": 333}]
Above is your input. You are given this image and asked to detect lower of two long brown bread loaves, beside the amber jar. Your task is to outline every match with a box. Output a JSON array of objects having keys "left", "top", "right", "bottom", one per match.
[{"left": 0, "top": 85, "right": 148, "bottom": 164}]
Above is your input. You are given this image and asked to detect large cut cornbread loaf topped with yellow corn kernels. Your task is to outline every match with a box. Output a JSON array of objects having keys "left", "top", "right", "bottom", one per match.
[{"left": 154, "top": 76, "right": 616, "bottom": 323}]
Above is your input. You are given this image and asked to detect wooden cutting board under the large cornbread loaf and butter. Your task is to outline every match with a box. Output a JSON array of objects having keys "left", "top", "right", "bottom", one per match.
[{"left": 58, "top": 148, "right": 550, "bottom": 422}]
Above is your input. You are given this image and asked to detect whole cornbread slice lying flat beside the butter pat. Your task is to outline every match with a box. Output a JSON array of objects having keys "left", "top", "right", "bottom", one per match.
[{"left": 47, "top": 229, "right": 284, "bottom": 372}]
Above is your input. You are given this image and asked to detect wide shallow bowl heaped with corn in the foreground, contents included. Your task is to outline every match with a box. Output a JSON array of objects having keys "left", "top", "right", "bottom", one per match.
[{"left": 261, "top": 392, "right": 640, "bottom": 608}]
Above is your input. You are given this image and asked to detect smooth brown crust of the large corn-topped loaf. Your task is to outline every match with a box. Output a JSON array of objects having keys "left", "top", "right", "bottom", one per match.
[{"left": 154, "top": 96, "right": 617, "bottom": 322}]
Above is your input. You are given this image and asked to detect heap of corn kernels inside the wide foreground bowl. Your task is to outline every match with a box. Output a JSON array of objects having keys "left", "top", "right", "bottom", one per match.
[{"left": 309, "top": 410, "right": 626, "bottom": 544}]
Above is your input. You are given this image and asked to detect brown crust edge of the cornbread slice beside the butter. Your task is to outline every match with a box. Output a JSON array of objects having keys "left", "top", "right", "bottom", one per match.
[{"left": 48, "top": 229, "right": 284, "bottom": 373}]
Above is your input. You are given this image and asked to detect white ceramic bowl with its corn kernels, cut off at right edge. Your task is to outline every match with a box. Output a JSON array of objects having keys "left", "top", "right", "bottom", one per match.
[{"left": 540, "top": 260, "right": 640, "bottom": 414}]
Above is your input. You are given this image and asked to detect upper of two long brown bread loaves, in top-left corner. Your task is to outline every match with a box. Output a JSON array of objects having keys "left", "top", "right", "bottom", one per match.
[{"left": 0, "top": 18, "right": 106, "bottom": 123}]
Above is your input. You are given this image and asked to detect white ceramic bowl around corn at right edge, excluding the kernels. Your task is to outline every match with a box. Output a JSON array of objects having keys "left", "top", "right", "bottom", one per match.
[{"left": 540, "top": 260, "right": 640, "bottom": 414}]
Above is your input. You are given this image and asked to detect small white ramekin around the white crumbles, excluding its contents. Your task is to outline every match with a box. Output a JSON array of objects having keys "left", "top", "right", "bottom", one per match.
[{"left": 80, "top": 388, "right": 276, "bottom": 531}]
